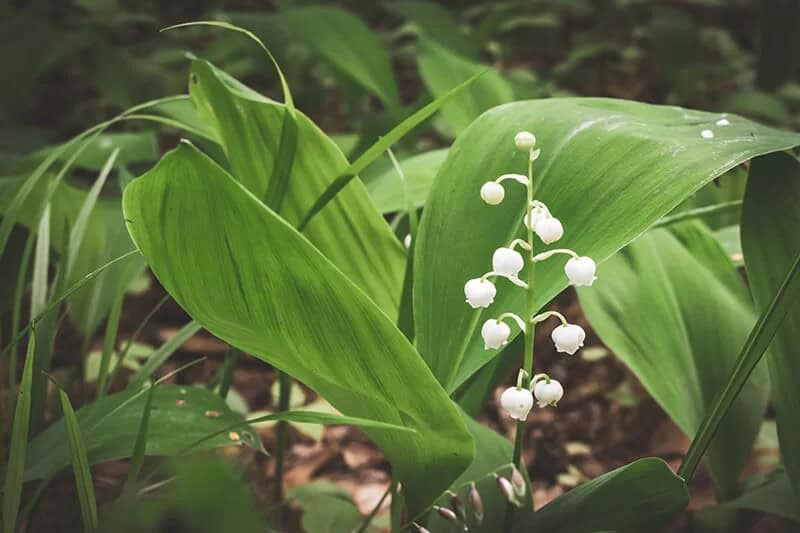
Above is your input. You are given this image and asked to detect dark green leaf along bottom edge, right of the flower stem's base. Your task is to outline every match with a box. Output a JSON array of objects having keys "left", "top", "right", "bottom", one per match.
[{"left": 514, "top": 457, "right": 689, "bottom": 533}]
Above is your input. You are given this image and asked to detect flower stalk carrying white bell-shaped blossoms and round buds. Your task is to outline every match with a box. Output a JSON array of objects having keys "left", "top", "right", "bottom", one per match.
[{"left": 464, "top": 131, "right": 597, "bottom": 468}]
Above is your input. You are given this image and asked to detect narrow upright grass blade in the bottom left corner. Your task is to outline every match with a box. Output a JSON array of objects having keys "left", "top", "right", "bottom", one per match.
[{"left": 3, "top": 329, "right": 36, "bottom": 533}]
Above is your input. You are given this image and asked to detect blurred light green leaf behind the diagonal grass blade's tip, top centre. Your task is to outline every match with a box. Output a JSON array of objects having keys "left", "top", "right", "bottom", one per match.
[{"left": 417, "top": 39, "right": 514, "bottom": 138}]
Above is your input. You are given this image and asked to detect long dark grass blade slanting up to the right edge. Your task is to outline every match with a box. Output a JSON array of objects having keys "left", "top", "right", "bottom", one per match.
[{"left": 678, "top": 247, "right": 800, "bottom": 482}]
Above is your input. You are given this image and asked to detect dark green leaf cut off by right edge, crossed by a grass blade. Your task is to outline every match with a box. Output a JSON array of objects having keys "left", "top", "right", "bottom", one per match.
[{"left": 741, "top": 154, "right": 800, "bottom": 501}]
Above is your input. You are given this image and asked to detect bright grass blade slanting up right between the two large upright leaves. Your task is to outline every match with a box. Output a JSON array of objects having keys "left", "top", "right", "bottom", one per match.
[{"left": 297, "top": 70, "right": 486, "bottom": 231}]
